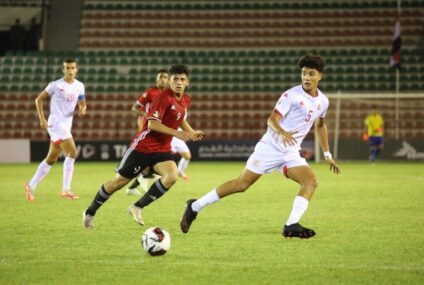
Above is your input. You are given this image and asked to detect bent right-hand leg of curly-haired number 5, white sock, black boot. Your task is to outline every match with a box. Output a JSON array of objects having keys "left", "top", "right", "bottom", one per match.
[{"left": 283, "top": 165, "right": 318, "bottom": 238}]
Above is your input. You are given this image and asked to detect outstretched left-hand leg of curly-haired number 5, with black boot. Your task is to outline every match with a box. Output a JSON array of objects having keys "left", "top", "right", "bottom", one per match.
[{"left": 180, "top": 169, "right": 262, "bottom": 233}]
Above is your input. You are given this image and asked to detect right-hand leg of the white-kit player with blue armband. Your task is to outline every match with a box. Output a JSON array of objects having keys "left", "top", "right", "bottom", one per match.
[{"left": 60, "top": 137, "right": 79, "bottom": 200}]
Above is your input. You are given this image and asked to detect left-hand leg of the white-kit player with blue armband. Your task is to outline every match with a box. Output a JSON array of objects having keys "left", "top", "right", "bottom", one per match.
[{"left": 24, "top": 142, "right": 62, "bottom": 201}]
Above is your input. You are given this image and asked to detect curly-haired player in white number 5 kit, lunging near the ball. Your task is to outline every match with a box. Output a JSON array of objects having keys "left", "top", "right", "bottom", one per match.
[{"left": 180, "top": 54, "right": 340, "bottom": 238}]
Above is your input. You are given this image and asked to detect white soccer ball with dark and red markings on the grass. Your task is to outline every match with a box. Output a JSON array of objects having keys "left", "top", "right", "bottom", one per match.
[{"left": 141, "top": 227, "right": 171, "bottom": 256}]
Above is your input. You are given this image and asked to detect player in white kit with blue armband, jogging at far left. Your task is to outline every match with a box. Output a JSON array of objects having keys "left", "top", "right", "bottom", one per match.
[{"left": 24, "top": 59, "right": 87, "bottom": 201}]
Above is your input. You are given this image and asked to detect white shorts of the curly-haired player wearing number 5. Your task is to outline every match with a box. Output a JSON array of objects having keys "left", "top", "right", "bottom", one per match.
[{"left": 246, "top": 141, "right": 308, "bottom": 174}]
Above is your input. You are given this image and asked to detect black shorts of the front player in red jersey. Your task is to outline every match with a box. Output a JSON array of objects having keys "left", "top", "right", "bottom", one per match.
[{"left": 115, "top": 148, "right": 175, "bottom": 179}]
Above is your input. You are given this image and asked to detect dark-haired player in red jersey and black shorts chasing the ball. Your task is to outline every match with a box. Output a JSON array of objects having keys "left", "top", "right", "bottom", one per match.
[{"left": 83, "top": 65, "right": 203, "bottom": 229}]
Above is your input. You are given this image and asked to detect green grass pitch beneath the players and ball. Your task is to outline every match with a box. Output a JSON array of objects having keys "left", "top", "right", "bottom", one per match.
[{"left": 0, "top": 162, "right": 424, "bottom": 284}]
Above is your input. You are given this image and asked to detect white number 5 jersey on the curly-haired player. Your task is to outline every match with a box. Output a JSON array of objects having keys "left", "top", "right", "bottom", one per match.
[{"left": 261, "top": 85, "right": 329, "bottom": 152}]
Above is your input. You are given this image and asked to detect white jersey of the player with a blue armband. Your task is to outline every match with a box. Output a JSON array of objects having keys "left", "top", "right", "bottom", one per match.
[{"left": 45, "top": 78, "right": 85, "bottom": 128}]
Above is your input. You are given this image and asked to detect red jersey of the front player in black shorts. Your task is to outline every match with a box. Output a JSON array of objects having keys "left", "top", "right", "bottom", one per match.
[{"left": 130, "top": 89, "right": 191, "bottom": 153}]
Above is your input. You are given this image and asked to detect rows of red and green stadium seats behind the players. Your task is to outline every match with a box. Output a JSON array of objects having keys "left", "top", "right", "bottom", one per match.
[{"left": 0, "top": 0, "right": 424, "bottom": 140}]
